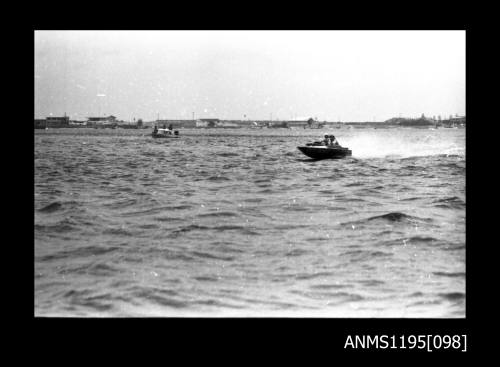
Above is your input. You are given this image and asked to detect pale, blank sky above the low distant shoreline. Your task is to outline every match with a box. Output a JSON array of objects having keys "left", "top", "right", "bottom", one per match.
[{"left": 35, "top": 31, "right": 465, "bottom": 121}]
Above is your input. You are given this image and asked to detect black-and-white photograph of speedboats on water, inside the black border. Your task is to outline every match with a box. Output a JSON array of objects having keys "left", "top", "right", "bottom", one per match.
[{"left": 34, "top": 30, "right": 464, "bottom": 319}]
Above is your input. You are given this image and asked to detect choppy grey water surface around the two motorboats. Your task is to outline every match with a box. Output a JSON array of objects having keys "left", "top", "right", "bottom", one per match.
[{"left": 34, "top": 128, "right": 465, "bottom": 317}]
